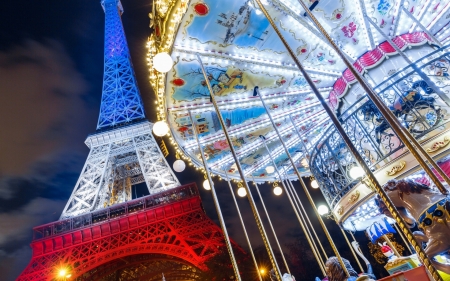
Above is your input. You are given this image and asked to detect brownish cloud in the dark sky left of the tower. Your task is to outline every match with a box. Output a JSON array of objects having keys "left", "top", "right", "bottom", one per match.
[{"left": 0, "top": 40, "right": 92, "bottom": 175}]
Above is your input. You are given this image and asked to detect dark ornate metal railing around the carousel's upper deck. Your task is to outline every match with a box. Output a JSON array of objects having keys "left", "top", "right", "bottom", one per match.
[{"left": 310, "top": 46, "right": 450, "bottom": 208}]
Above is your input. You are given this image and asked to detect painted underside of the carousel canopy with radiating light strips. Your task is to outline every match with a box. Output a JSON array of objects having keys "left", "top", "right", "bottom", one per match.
[{"left": 148, "top": 0, "right": 450, "bottom": 181}]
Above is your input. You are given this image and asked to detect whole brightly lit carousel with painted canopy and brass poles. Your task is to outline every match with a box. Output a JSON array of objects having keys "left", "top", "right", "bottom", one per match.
[{"left": 147, "top": 0, "right": 450, "bottom": 281}]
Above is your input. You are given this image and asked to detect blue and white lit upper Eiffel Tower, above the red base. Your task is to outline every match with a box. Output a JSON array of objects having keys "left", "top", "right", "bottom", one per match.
[{"left": 60, "top": 0, "right": 180, "bottom": 219}]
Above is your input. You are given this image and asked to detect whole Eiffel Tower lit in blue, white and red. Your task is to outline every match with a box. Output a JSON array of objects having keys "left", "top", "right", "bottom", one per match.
[{"left": 18, "top": 0, "right": 224, "bottom": 280}]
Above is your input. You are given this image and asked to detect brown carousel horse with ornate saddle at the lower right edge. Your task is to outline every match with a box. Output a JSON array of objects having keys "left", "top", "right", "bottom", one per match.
[{"left": 376, "top": 180, "right": 450, "bottom": 273}]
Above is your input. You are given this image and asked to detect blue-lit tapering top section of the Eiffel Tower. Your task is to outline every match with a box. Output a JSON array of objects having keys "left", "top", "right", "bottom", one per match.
[{"left": 97, "top": 0, "right": 145, "bottom": 130}]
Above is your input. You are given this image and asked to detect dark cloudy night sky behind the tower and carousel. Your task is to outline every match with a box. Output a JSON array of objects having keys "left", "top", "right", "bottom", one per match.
[{"left": 0, "top": 0, "right": 366, "bottom": 280}]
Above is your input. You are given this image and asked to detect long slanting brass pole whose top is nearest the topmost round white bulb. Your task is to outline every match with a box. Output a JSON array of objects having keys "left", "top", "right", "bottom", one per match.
[{"left": 197, "top": 54, "right": 281, "bottom": 281}]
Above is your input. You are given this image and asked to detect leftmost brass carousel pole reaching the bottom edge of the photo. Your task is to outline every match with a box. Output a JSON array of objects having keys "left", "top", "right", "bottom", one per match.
[{"left": 188, "top": 110, "right": 241, "bottom": 281}]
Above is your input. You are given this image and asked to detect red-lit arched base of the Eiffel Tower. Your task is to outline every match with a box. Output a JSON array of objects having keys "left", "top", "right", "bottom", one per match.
[{"left": 17, "top": 184, "right": 224, "bottom": 281}]
